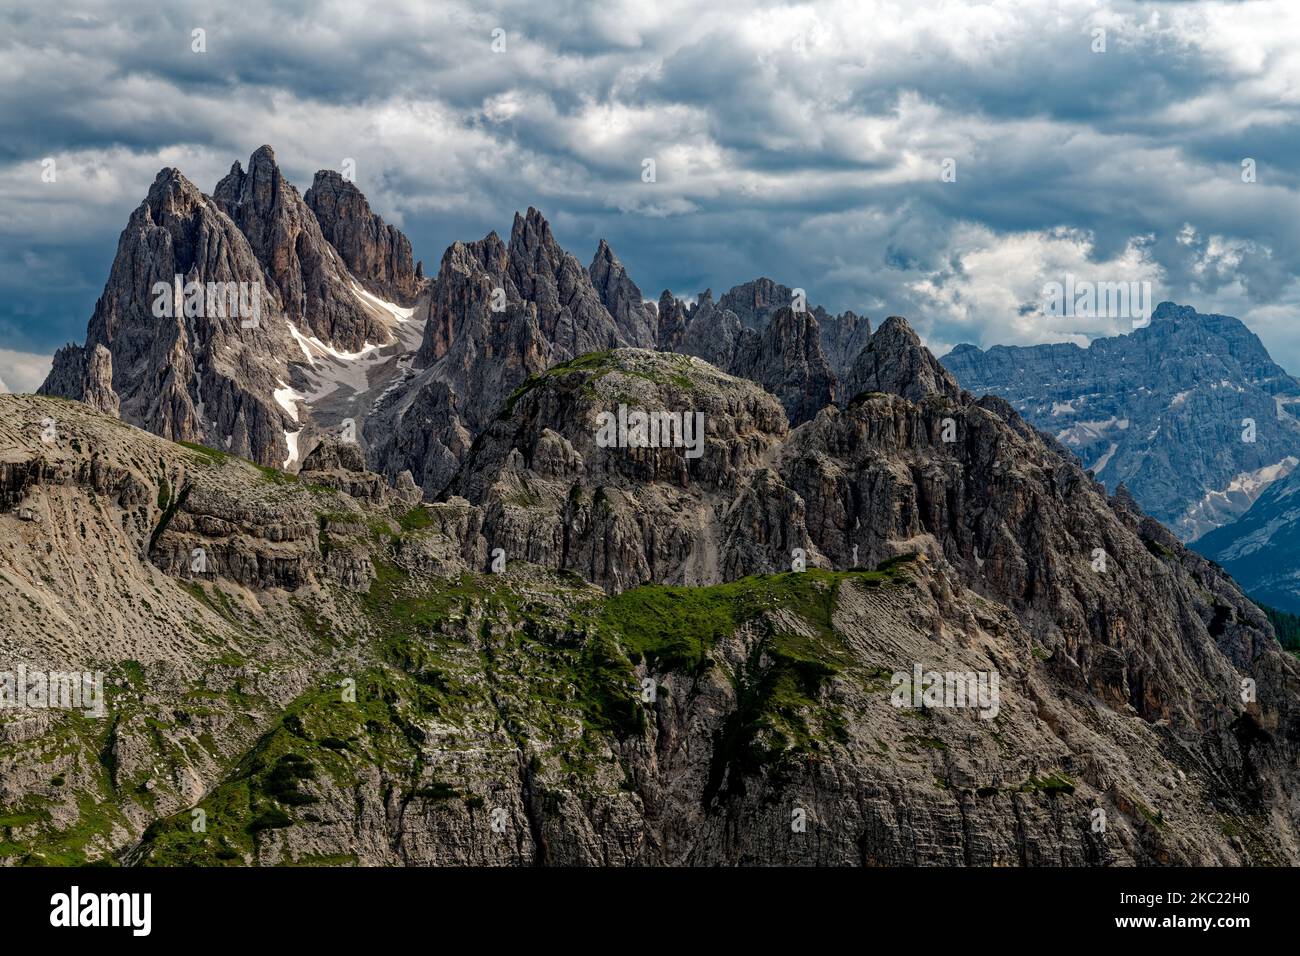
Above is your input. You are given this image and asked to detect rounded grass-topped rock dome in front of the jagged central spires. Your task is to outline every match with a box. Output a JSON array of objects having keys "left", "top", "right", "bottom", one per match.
[{"left": 447, "top": 350, "right": 787, "bottom": 591}]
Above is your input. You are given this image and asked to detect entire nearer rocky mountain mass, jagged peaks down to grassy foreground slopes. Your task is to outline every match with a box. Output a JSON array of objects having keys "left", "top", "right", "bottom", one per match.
[{"left": 17, "top": 150, "right": 1300, "bottom": 865}]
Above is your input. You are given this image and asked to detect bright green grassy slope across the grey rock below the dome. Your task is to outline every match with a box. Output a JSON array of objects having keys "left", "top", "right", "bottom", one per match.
[{"left": 129, "top": 564, "right": 906, "bottom": 865}]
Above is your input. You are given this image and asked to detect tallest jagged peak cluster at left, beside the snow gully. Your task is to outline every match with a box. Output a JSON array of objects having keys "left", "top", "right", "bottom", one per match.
[{"left": 42, "top": 147, "right": 441, "bottom": 468}]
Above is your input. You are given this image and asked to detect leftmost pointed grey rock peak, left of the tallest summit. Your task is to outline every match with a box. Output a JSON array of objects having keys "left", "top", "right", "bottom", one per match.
[{"left": 42, "top": 153, "right": 300, "bottom": 464}]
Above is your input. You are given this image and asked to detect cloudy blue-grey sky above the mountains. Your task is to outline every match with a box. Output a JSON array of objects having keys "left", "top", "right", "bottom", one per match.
[{"left": 0, "top": 0, "right": 1300, "bottom": 390}]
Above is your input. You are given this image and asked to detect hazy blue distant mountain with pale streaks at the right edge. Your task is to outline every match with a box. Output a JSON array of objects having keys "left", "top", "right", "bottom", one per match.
[{"left": 943, "top": 302, "right": 1300, "bottom": 540}]
